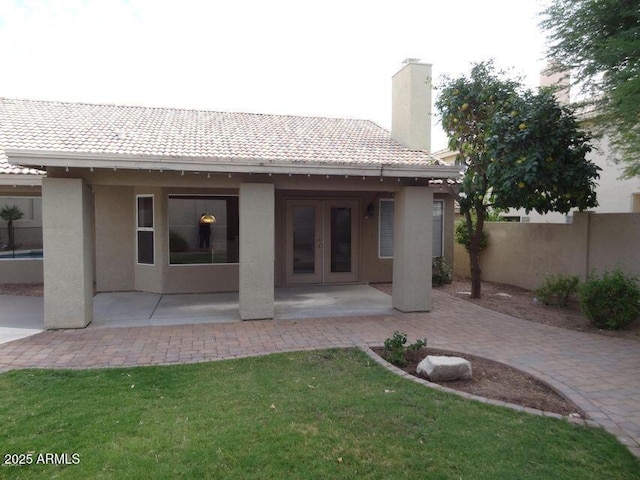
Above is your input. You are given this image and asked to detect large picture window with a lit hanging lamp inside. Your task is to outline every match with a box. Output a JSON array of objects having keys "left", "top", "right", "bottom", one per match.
[{"left": 169, "top": 195, "right": 239, "bottom": 265}]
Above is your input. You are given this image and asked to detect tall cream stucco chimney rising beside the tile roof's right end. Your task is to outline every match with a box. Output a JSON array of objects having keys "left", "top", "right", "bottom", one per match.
[{"left": 391, "top": 58, "right": 431, "bottom": 151}]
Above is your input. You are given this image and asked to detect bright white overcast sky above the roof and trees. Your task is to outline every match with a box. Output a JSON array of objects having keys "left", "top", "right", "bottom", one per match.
[{"left": 0, "top": 0, "right": 546, "bottom": 151}]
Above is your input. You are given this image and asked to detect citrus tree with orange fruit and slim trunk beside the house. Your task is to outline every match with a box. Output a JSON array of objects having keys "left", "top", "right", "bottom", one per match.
[{"left": 436, "top": 62, "right": 599, "bottom": 298}]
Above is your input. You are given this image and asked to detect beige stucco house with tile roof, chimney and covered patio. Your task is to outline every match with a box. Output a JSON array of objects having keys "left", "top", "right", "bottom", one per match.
[{"left": 0, "top": 60, "right": 459, "bottom": 328}]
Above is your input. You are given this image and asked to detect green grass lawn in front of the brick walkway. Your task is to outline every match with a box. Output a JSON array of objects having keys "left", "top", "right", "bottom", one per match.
[{"left": 0, "top": 350, "right": 640, "bottom": 480}]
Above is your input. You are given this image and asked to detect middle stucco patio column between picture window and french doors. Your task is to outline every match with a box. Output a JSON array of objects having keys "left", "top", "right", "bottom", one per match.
[{"left": 239, "top": 183, "right": 275, "bottom": 320}]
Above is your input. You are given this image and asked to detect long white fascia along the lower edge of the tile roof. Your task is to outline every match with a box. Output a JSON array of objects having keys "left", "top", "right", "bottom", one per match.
[{"left": 5, "top": 148, "right": 460, "bottom": 178}]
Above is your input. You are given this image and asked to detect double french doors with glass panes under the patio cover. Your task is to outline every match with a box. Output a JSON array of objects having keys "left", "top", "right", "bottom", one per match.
[{"left": 285, "top": 200, "right": 359, "bottom": 284}]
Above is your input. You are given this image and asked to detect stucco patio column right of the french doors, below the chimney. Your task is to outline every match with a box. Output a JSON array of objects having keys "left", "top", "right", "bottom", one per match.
[{"left": 392, "top": 187, "right": 433, "bottom": 312}]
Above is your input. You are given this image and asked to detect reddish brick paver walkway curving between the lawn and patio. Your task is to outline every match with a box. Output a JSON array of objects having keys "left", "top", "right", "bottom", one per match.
[{"left": 0, "top": 291, "right": 640, "bottom": 456}]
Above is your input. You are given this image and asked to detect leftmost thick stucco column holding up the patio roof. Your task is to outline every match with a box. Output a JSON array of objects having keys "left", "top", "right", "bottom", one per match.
[{"left": 42, "top": 178, "right": 93, "bottom": 328}]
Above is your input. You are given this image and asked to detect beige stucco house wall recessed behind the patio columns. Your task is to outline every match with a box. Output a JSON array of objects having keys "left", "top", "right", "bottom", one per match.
[{"left": 48, "top": 169, "right": 454, "bottom": 293}]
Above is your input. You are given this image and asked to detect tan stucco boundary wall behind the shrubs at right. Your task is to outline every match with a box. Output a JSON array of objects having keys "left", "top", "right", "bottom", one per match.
[{"left": 456, "top": 213, "right": 640, "bottom": 290}]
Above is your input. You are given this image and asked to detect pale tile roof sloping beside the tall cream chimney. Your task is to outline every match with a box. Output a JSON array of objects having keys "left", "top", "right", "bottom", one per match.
[{"left": 0, "top": 98, "right": 450, "bottom": 171}]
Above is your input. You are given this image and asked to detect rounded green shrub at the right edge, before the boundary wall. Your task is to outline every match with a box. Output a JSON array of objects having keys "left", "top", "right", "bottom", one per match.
[{"left": 578, "top": 268, "right": 640, "bottom": 330}]
